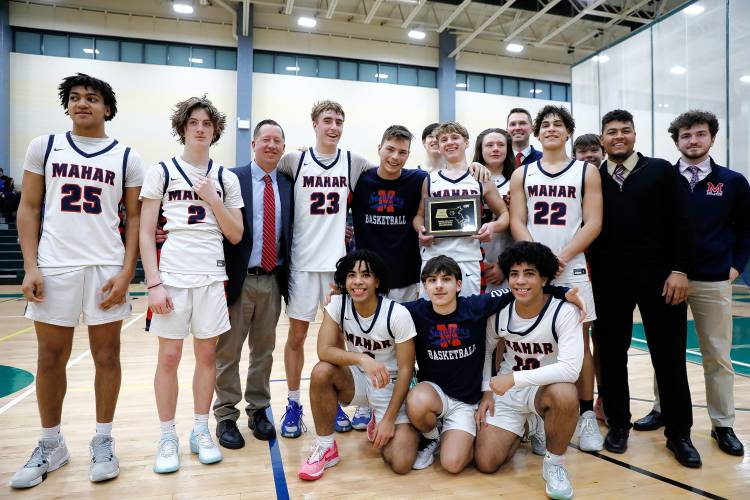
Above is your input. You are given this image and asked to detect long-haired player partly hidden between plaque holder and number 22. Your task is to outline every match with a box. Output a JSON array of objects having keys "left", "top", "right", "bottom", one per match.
[{"left": 473, "top": 128, "right": 515, "bottom": 293}]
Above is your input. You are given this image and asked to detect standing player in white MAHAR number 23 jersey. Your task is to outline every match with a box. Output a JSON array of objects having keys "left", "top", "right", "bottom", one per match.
[{"left": 277, "top": 101, "right": 370, "bottom": 438}]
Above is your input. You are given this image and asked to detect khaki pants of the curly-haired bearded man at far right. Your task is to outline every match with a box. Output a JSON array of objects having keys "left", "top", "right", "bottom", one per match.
[{"left": 654, "top": 280, "right": 734, "bottom": 427}]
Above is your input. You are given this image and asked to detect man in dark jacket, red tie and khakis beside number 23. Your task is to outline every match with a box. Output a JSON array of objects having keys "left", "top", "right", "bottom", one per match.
[{"left": 214, "top": 120, "right": 292, "bottom": 449}]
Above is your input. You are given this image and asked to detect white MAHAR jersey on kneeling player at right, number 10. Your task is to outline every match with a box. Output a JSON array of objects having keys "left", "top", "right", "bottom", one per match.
[{"left": 488, "top": 297, "right": 565, "bottom": 373}]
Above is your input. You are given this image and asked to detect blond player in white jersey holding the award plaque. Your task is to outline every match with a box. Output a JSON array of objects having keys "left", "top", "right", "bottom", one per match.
[{"left": 414, "top": 122, "right": 509, "bottom": 297}]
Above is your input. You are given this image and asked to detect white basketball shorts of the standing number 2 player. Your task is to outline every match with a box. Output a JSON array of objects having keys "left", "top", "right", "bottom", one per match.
[{"left": 149, "top": 281, "right": 230, "bottom": 340}]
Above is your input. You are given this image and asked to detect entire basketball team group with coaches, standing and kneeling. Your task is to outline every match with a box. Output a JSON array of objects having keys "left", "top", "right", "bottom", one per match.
[{"left": 10, "top": 73, "right": 750, "bottom": 499}]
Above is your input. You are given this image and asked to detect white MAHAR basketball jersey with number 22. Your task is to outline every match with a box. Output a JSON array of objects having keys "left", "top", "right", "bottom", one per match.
[{"left": 523, "top": 160, "right": 589, "bottom": 283}]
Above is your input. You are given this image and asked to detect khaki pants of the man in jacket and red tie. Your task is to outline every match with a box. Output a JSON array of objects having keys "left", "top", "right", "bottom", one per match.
[{"left": 214, "top": 274, "right": 281, "bottom": 422}]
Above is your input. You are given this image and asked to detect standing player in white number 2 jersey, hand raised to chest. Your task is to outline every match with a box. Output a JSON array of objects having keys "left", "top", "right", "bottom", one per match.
[{"left": 140, "top": 97, "right": 244, "bottom": 473}]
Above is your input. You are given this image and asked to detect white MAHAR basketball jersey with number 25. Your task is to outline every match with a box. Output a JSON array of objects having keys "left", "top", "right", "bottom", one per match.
[{"left": 38, "top": 132, "right": 135, "bottom": 272}]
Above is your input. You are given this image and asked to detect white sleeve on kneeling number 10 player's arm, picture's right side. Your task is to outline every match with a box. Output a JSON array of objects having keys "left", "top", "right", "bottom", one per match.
[{"left": 513, "top": 304, "right": 583, "bottom": 387}]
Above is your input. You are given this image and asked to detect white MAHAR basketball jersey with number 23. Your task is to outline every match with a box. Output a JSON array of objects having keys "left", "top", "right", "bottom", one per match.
[{"left": 291, "top": 148, "right": 351, "bottom": 272}]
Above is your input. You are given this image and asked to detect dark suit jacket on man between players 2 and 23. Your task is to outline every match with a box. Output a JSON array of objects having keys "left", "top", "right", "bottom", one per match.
[{"left": 224, "top": 164, "right": 292, "bottom": 304}]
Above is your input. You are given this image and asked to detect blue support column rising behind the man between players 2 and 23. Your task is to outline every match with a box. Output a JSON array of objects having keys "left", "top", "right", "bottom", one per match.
[{"left": 234, "top": 2, "right": 253, "bottom": 166}]
